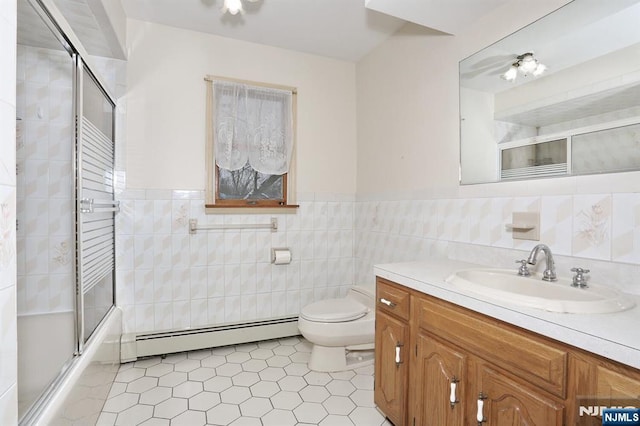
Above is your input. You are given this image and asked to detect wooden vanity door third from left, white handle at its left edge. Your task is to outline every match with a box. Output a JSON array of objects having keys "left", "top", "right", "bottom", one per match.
[{"left": 466, "top": 360, "right": 564, "bottom": 426}]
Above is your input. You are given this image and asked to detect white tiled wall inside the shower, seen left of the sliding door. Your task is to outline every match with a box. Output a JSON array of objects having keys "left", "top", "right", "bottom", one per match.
[{"left": 16, "top": 45, "right": 74, "bottom": 315}]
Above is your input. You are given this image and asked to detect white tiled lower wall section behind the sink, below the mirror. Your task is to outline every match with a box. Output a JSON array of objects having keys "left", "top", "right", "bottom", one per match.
[{"left": 355, "top": 193, "right": 640, "bottom": 294}]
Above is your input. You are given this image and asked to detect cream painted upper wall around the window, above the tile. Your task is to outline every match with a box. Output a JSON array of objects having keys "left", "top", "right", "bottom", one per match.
[{"left": 126, "top": 20, "right": 356, "bottom": 194}]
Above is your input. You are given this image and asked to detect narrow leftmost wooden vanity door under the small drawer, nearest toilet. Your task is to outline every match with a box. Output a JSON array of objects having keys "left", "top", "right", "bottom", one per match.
[{"left": 374, "top": 310, "right": 410, "bottom": 426}]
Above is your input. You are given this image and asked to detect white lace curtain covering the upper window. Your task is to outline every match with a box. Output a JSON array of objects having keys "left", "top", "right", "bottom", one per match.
[{"left": 213, "top": 80, "right": 293, "bottom": 175}]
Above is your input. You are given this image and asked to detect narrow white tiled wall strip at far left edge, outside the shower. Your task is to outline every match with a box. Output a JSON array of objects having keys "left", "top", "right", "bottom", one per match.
[{"left": 0, "top": 0, "right": 18, "bottom": 425}]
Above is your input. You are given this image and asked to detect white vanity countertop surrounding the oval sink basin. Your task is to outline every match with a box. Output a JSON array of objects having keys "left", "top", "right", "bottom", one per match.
[{"left": 374, "top": 260, "right": 640, "bottom": 368}]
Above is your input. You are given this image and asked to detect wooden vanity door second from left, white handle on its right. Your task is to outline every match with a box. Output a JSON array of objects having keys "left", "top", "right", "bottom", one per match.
[{"left": 409, "top": 333, "right": 464, "bottom": 426}]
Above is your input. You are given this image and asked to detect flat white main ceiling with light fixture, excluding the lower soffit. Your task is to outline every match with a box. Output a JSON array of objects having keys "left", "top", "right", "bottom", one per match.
[{"left": 122, "top": 0, "right": 405, "bottom": 61}]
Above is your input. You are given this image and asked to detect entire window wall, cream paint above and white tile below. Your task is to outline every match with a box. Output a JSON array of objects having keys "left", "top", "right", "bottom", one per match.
[{"left": 117, "top": 20, "right": 360, "bottom": 332}]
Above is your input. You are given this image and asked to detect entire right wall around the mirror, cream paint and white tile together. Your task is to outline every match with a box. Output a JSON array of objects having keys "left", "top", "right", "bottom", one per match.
[{"left": 355, "top": 0, "right": 640, "bottom": 293}]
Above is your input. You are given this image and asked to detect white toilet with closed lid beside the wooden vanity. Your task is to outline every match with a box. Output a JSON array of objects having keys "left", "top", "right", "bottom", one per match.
[{"left": 298, "top": 286, "right": 375, "bottom": 372}]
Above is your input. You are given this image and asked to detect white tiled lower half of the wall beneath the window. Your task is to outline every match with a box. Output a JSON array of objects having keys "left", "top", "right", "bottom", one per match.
[{"left": 116, "top": 190, "right": 356, "bottom": 333}]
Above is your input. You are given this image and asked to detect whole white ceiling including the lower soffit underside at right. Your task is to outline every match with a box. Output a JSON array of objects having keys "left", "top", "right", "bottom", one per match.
[{"left": 122, "top": 0, "right": 508, "bottom": 61}]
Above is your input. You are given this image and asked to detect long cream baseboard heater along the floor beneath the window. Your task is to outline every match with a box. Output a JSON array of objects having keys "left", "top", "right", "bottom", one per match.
[{"left": 120, "top": 316, "right": 300, "bottom": 362}]
